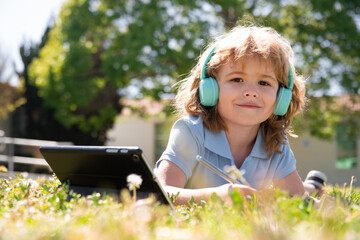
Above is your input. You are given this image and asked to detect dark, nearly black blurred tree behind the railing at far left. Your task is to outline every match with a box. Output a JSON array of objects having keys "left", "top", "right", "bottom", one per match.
[{"left": 11, "top": 24, "right": 114, "bottom": 145}]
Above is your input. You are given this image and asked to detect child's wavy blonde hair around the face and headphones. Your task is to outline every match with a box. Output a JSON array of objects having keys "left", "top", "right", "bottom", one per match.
[{"left": 175, "top": 26, "right": 306, "bottom": 156}]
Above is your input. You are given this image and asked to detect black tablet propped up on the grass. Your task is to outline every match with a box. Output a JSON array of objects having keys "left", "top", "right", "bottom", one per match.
[{"left": 40, "top": 146, "right": 171, "bottom": 205}]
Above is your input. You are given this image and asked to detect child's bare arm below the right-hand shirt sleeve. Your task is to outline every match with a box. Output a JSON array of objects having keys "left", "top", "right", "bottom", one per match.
[{"left": 274, "top": 170, "right": 305, "bottom": 196}]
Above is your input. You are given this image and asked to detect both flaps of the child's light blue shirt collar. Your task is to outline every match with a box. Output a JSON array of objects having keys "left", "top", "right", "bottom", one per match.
[{"left": 204, "top": 127, "right": 268, "bottom": 159}]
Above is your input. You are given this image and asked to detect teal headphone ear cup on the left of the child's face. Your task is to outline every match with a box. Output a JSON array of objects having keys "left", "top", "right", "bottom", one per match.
[{"left": 199, "top": 77, "right": 219, "bottom": 107}]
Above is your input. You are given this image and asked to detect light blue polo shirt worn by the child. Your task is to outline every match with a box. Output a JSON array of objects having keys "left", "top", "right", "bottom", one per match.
[{"left": 155, "top": 115, "right": 296, "bottom": 189}]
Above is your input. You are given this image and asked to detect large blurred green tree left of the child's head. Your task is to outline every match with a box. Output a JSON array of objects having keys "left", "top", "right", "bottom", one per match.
[{"left": 30, "top": 0, "right": 219, "bottom": 139}]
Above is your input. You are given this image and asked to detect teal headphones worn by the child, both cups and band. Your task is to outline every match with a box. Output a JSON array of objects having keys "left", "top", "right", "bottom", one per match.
[{"left": 199, "top": 48, "right": 294, "bottom": 116}]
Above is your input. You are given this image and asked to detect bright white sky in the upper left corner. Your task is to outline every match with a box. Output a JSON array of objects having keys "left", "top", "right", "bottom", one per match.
[{"left": 0, "top": 0, "right": 65, "bottom": 85}]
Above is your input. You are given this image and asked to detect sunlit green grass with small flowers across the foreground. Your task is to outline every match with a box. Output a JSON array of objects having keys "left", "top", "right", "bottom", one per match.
[{"left": 0, "top": 175, "right": 360, "bottom": 240}]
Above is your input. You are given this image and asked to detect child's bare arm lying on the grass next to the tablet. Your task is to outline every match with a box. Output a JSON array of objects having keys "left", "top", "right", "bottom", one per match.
[{"left": 156, "top": 160, "right": 256, "bottom": 205}]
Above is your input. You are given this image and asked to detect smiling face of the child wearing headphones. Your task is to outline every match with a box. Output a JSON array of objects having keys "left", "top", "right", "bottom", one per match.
[{"left": 216, "top": 57, "right": 279, "bottom": 128}]
